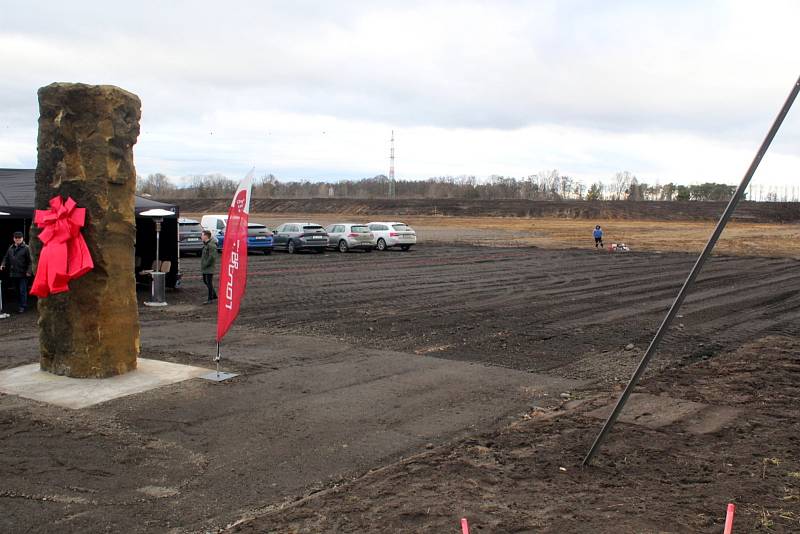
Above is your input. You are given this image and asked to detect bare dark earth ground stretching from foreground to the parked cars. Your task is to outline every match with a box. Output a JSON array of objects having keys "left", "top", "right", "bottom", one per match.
[{"left": 0, "top": 228, "right": 800, "bottom": 533}]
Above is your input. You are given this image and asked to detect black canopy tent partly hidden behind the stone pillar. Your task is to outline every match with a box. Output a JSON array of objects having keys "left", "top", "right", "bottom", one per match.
[{"left": 0, "top": 169, "right": 180, "bottom": 287}]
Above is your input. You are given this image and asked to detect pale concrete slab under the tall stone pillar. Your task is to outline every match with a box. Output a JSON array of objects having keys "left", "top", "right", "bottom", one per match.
[{"left": 0, "top": 358, "right": 209, "bottom": 409}]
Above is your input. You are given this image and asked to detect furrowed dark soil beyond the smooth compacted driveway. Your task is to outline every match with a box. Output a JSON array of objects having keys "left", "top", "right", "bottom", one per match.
[{"left": 173, "top": 245, "right": 800, "bottom": 371}]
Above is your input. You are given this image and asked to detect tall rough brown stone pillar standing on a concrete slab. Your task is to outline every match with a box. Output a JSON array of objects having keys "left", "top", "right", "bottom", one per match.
[{"left": 32, "top": 83, "right": 141, "bottom": 378}]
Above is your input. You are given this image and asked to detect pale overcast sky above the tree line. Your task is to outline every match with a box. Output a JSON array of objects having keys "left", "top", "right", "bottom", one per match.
[{"left": 0, "top": 0, "right": 800, "bottom": 186}]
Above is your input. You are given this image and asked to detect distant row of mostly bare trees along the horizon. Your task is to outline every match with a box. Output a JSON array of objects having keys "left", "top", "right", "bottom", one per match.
[{"left": 137, "top": 170, "right": 756, "bottom": 201}]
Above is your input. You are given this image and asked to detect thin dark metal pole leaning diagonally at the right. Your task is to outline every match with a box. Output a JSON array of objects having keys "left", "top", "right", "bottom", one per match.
[{"left": 583, "top": 73, "right": 800, "bottom": 465}]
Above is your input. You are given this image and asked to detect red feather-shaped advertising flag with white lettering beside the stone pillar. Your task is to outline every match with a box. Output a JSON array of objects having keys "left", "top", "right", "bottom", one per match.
[{"left": 217, "top": 171, "right": 253, "bottom": 343}]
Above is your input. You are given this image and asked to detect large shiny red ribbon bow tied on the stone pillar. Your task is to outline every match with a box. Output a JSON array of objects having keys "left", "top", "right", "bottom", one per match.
[{"left": 31, "top": 196, "right": 94, "bottom": 297}]
